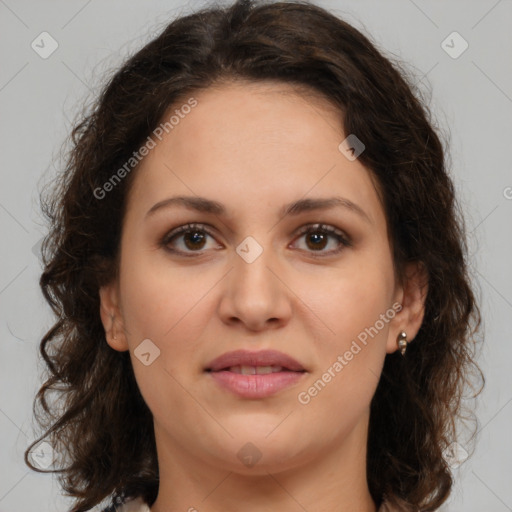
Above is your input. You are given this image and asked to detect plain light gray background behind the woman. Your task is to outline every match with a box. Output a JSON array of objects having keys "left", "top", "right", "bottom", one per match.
[{"left": 0, "top": 0, "right": 512, "bottom": 512}]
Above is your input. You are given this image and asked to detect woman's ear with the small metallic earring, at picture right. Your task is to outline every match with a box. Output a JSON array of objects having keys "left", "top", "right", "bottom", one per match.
[{"left": 386, "top": 262, "right": 428, "bottom": 354}]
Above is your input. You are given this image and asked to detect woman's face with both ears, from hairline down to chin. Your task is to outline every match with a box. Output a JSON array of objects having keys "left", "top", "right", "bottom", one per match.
[{"left": 100, "top": 83, "right": 422, "bottom": 474}]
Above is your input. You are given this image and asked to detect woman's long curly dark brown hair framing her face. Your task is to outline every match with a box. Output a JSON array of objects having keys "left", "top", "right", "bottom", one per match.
[{"left": 25, "top": 0, "right": 483, "bottom": 512}]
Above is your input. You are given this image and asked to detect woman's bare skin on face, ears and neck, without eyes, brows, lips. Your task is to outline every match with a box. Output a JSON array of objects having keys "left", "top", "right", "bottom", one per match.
[{"left": 100, "top": 83, "right": 426, "bottom": 512}]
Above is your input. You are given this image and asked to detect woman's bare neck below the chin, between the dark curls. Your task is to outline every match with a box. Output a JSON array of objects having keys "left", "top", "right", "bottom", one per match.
[{"left": 151, "top": 410, "right": 377, "bottom": 512}]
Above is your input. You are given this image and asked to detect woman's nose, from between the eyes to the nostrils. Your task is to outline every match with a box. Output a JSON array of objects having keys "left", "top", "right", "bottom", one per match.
[{"left": 218, "top": 242, "right": 293, "bottom": 331}]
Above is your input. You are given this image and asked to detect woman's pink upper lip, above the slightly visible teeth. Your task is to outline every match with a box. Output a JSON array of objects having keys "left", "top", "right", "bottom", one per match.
[{"left": 205, "top": 350, "right": 306, "bottom": 375}]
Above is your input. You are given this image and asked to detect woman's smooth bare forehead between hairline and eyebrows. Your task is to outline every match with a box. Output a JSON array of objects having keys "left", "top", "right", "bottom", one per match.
[{"left": 130, "top": 83, "right": 382, "bottom": 228}]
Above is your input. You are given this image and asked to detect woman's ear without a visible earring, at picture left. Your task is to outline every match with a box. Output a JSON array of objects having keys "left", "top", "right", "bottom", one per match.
[{"left": 99, "top": 281, "right": 128, "bottom": 352}]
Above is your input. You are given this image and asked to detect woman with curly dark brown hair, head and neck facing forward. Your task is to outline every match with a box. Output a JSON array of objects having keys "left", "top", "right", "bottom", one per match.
[{"left": 25, "top": 0, "right": 479, "bottom": 512}]
